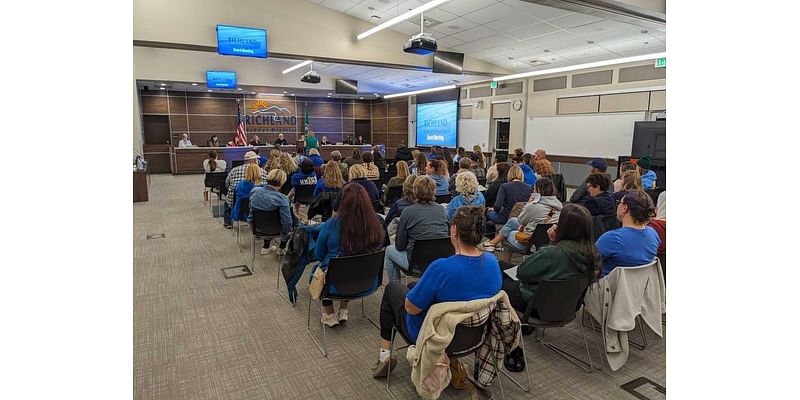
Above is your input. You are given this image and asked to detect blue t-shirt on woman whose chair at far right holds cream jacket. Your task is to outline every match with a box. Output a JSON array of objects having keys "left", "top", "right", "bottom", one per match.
[{"left": 596, "top": 226, "right": 661, "bottom": 278}]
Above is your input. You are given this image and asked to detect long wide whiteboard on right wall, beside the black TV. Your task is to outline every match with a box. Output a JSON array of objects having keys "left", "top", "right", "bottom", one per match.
[{"left": 525, "top": 112, "right": 646, "bottom": 159}]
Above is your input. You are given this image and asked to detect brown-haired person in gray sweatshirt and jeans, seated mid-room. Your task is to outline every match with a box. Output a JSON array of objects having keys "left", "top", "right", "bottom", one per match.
[{"left": 384, "top": 176, "right": 454, "bottom": 281}]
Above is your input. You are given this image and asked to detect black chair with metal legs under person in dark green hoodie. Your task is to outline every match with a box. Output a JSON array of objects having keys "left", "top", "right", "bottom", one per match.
[{"left": 521, "top": 277, "right": 602, "bottom": 376}]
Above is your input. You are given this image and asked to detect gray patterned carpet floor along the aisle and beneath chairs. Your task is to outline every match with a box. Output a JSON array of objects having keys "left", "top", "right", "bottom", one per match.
[{"left": 133, "top": 175, "right": 666, "bottom": 400}]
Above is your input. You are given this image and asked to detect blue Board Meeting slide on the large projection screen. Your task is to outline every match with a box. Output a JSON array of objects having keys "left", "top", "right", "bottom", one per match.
[{"left": 417, "top": 100, "right": 458, "bottom": 147}]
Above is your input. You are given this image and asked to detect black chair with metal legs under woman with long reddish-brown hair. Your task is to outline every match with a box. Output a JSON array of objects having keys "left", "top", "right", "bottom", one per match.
[{"left": 306, "top": 249, "right": 386, "bottom": 357}]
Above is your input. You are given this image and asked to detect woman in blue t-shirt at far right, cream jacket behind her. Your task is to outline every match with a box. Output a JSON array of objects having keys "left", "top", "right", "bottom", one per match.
[{"left": 597, "top": 190, "right": 661, "bottom": 277}]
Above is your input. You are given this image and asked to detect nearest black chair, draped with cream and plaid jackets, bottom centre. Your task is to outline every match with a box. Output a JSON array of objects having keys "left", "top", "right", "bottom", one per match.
[{"left": 386, "top": 310, "right": 506, "bottom": 400}]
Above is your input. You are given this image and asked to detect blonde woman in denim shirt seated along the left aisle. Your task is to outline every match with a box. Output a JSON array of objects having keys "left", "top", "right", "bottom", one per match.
[{"left": 247, "top": 169, "right": 298, "bottom": 255}]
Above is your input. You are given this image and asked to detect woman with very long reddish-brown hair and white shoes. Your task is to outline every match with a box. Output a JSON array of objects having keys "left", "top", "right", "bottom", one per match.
[{"left": 311, "top": 183, "right": 383, "bottom": 327}]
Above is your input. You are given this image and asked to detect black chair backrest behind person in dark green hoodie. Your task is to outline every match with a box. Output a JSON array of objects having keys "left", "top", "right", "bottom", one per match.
[{"left": 524, "top": 277, "right": 590, "bottom": 322}]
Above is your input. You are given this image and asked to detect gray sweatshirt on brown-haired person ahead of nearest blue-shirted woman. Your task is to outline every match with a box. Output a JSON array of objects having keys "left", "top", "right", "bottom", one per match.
[{"left": 395, "top": 203, "right": 450, "bottom": 262}]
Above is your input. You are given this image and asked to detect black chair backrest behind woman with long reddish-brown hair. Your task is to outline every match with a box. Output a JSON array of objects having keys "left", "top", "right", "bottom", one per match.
[{"left": 325, "top": 249, "right": 386, "bottom": 296}]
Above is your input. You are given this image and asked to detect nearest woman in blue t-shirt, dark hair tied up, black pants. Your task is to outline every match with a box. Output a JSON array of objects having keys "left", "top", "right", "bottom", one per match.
[{"left": 373, "top": 206, "right": 502, "bottom": 379}]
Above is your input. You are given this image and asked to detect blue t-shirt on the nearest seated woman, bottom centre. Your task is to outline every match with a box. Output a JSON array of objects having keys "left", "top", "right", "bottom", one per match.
[{"left": 406, "top": 253, "right": 503, "bottom": 342}]
